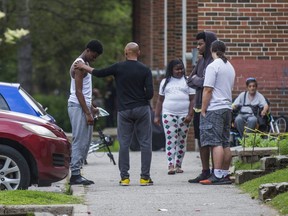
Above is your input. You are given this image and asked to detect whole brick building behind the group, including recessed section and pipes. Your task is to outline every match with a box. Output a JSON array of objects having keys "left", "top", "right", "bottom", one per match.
[{"left": 133, "top": 0, "right": 288, "bottom": 149}]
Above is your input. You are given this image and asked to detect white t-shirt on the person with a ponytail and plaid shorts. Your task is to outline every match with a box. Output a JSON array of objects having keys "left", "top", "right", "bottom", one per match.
[{"left": 203, "top": 58, "right": 235, "bottom": 111}]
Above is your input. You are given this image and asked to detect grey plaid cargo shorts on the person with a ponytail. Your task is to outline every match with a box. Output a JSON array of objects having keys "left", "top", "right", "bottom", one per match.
[{"left": 200, "top": 109, "right": 232, "bottom": 148}]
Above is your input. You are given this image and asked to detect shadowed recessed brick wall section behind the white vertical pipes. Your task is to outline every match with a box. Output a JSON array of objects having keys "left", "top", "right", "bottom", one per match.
[{"left": 133, "top": 0, "right": 198, "bottom": 150}]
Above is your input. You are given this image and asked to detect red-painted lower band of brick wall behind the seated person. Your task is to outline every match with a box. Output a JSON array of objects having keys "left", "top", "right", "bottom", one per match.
[{"left": 231, "top": 58, "right": 288, "bottom": 116}]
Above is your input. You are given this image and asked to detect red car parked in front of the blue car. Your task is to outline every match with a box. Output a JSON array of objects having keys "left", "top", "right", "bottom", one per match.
[{"left": 0, "top": 110, "right": 71, "bottom": 190}]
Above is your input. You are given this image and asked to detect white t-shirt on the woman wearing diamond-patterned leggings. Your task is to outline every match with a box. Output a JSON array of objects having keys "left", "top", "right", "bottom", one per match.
[{"left": 159, "top": 76, "right": 195, "bottom": 116}]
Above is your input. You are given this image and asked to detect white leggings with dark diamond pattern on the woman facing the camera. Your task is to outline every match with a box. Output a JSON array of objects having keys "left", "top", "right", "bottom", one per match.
[{"left": 162, "top": 114, "right": 189, "bottom": 167}]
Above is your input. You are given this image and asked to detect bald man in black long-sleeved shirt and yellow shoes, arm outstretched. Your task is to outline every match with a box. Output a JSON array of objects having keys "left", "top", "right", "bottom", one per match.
[{"left": 76, "top": 42, "right": 153, "bottom": 186}]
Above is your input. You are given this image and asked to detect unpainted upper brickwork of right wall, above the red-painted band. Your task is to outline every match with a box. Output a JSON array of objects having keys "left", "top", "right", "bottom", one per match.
[{"left": 198, "top": 0, "right": 288, "bottom": 60}]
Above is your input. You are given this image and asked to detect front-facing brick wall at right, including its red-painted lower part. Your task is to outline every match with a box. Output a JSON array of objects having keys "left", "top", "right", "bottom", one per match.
[{"left": 198, "top": 0, "right": 288, "bottom": 116}]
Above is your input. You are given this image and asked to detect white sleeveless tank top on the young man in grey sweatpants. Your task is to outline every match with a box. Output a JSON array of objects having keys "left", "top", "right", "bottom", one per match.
[{"left": 68, "top": 58, "right": 92, "bottom": 107}]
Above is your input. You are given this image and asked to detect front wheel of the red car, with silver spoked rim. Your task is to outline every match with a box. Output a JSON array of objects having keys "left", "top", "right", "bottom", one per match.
[{"left": 0, "top": 145, "right": 30, "bottom": 190}]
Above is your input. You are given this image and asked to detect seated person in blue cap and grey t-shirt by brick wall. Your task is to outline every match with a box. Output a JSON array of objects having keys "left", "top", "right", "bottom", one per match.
[{"left": 232, "top": 78, "right": 269, "bottom": 138}]
